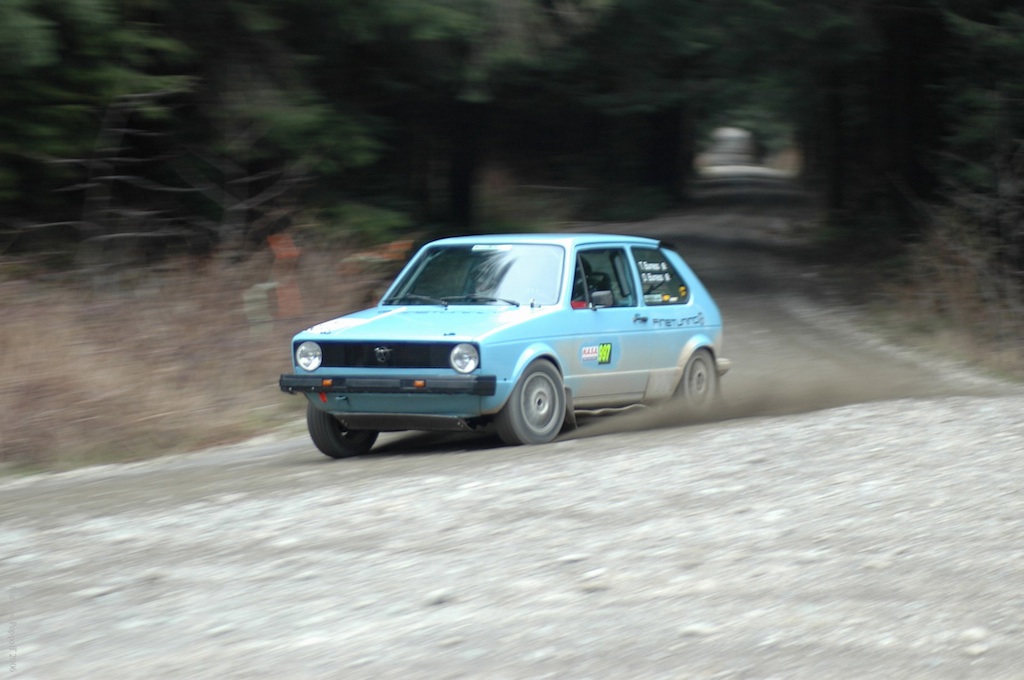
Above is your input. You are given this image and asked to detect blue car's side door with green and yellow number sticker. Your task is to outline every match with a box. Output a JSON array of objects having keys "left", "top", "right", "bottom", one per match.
[{"left": 566, "top": 247, "right": 649, "bottom": 408}]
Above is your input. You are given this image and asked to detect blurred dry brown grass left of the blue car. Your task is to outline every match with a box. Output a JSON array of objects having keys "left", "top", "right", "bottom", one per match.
[{"left": 0, "top": 245, "right": 393, "bottom": 469}]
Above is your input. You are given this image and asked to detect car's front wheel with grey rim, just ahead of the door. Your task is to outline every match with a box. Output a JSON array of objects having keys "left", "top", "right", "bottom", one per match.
[{"left": 495, "top": 359, "right": 565, "bottom": 447}]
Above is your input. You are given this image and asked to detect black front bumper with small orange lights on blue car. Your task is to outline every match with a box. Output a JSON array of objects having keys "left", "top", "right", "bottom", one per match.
[{"left": 280, "top": 373, "right": 498, "bottom": 396}]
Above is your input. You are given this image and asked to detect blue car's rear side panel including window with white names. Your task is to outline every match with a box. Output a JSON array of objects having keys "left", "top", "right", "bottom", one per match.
[{"left": 631, "top": 247, "right": 706, "bottom": 398}]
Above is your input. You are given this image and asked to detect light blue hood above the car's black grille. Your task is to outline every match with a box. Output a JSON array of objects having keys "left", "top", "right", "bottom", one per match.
[{"left": 296, "top": 305, "right": 555, "bottom": 342}]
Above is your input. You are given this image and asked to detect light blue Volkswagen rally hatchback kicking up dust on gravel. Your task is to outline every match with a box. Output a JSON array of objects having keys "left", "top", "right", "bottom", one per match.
[{"left": 281, "top": 235, "right": 729, "bottom": 458}]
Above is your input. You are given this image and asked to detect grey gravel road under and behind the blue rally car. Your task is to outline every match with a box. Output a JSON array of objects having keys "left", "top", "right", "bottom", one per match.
[{"left": 0, "top": 180, "right": 1024, "bottom": 680}]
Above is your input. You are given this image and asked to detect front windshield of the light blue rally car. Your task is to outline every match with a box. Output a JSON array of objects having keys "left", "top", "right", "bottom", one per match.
[{"left": 384, "top": 244, "right": 564, "bottom": 305}]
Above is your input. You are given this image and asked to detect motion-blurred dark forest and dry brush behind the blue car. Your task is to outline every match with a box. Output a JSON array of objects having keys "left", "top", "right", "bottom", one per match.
[{"left": 0, "top": 0, "right": 1024, "bottom": 469}]
